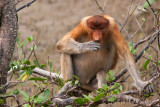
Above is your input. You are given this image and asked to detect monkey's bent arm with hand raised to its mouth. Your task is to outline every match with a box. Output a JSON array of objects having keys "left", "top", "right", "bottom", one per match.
[{"left": 56, "top": 24, "right": 100, "bottom": 54}]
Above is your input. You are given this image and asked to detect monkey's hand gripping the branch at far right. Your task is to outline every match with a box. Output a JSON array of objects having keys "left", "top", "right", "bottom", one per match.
[{"left": 134, "top": 81, "right": 154, "bottom": 94}]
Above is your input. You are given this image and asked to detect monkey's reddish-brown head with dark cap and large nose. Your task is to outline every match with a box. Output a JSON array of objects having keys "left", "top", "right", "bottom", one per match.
[{"left": 86, "top": 15, "right": 109, "bottom": 41}]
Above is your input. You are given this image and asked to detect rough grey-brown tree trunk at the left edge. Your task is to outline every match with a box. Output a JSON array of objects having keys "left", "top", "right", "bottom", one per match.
[{"left": 0, "top": 0, "right": 17, "bottom": 94}]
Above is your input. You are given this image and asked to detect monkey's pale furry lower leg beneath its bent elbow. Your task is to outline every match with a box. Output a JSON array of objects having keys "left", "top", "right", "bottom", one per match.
[{"left": 60, "top": 53, "right": 74, "bottom": 81}]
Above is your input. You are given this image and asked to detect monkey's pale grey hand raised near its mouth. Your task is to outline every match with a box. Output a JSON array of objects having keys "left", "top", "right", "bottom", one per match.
[{"left": 81, "top": 41, "right": 100, "bottom": 52}]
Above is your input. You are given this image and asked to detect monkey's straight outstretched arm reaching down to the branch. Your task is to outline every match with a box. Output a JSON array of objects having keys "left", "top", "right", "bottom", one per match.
[{"left": 113, "top": 25, "right": 147, "bottom": 91}]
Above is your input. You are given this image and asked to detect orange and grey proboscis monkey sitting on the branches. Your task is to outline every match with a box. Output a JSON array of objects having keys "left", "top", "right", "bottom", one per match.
[{"left": 57, "top": 15, "right": 152, "bottom": 91}]
